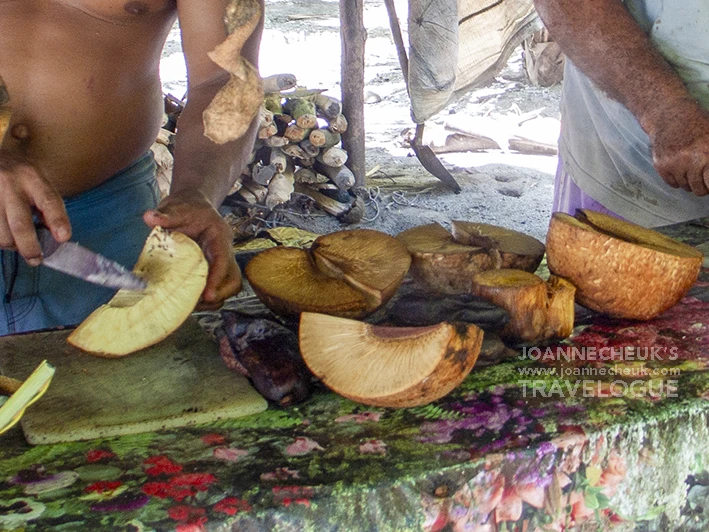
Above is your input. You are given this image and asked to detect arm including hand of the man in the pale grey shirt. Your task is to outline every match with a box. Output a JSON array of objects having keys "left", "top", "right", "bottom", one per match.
[{"left": 535, "top": 0, "right": 709, "bottom": 196}]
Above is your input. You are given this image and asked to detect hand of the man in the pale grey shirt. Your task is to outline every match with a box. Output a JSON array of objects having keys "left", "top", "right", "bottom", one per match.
[{"left": 650, "top": 99, "right": 709, "bottom": 196}]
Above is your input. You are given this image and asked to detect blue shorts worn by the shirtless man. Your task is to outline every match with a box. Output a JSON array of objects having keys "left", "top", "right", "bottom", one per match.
[{"left": 0, "top": 152, "right": 159, "bottom": 335}]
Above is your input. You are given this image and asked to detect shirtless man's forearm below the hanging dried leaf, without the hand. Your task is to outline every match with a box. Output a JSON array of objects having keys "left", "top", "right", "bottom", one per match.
[{"left": 170, "top": 76, "right": 256, "bottom": 207}]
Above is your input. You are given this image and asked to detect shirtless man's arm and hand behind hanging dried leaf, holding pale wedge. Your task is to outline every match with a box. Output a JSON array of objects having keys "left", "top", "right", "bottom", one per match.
[{"left": 145, "top": 0, "right": 264, "bottom": 308}]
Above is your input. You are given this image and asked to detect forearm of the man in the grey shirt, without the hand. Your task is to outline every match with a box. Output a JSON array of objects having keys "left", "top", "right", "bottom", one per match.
[{"left": 535, "top": 0, "right": 691, "bottom": 137}]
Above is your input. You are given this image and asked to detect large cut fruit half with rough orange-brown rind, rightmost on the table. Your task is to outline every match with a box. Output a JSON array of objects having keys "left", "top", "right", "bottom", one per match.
[{"left": 547, "top": 210, "right": 704, "bottom": 320}]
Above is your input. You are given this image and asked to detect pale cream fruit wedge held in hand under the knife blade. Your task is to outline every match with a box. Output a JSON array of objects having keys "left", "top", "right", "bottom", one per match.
[{"left": 67, "top": 227, "right": 208, "bottom": 357}]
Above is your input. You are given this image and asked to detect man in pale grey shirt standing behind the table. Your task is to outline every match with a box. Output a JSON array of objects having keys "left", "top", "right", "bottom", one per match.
[{"left": 535, "top": 0, "right": 709, "bottom": 227}]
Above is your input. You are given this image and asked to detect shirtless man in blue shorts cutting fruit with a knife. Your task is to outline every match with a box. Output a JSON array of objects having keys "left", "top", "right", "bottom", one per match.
[{"left": 0, "top": 0, "right": 263, "bottom": 334}]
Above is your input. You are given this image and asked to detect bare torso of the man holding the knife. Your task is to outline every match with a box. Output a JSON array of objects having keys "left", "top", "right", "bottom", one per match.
[{"left": 0, "top": 0, "right": 176, "bottom": 196}]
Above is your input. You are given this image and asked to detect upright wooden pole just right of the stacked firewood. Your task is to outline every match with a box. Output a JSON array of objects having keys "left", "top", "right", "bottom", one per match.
[{"left": 340, "top": 0, "right": 367, "bottom": 187}]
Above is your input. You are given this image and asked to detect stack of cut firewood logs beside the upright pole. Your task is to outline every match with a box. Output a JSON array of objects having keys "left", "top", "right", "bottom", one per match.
[{"left": 232, "top": 81, "right": 363, "bottom": 222}]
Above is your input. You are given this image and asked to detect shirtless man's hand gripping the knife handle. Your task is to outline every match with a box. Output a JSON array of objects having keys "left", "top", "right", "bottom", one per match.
[{"left": 0, "top": 152, "right": 71, "bottom": 266}]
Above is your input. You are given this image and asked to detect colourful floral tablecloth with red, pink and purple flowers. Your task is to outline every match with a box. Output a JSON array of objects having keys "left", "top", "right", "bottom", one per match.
[{"left": 0, "top": 222, "right": 709, "bottom": 532}]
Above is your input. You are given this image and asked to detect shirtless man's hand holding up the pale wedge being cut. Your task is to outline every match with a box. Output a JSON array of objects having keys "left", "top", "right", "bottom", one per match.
[{"left": 143, "top": 190, "right": 241, "bottom": 310}]
